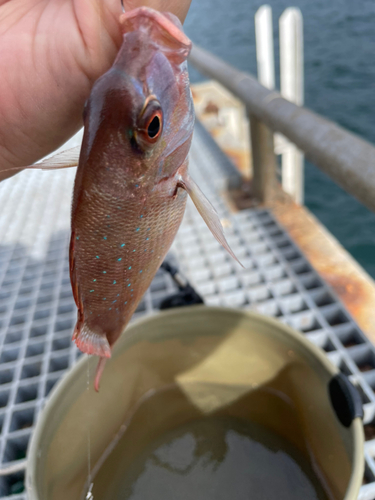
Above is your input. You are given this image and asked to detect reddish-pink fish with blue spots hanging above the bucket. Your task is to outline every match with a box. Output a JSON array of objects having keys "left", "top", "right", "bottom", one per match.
[{"left": 22, "top": 7, "right": 238, "bottom": 390}]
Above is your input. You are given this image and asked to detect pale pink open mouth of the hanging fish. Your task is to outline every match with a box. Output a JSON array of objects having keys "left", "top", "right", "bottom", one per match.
[{"left": 120, "top": 7, "right": 192, "bottom": 64}]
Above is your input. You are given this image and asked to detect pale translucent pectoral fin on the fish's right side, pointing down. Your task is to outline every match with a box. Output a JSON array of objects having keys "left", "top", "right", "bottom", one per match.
[{"left": 179, "top": 176, "right": 243, "bottom": 267}]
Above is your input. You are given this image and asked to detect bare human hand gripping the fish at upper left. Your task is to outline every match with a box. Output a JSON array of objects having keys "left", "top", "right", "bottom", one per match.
[{"left": 0, "top": 0, "right": 191, "bottom": 180}]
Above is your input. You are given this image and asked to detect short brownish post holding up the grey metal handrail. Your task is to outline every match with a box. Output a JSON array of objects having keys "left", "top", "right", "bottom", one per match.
[{"left": 247, "top": 111, "right": 276, "bottom": 203}]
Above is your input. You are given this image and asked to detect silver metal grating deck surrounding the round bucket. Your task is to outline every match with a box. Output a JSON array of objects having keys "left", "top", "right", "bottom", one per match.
[{"left": 0, "top": 124, "right": 375, "bottom": 500}]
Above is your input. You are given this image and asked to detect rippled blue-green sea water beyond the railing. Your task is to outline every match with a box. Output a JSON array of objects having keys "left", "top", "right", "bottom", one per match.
[{"left": 184, "top": 0, "right": 375, "bottom": 278}]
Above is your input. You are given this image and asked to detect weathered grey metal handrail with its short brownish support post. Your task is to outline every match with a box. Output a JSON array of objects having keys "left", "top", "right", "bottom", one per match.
[{"left": 189, "top": 45, "right": 375, "bottom": 212}]
